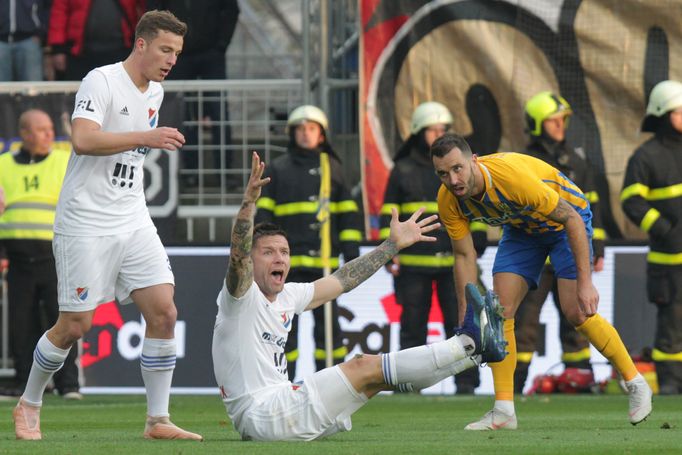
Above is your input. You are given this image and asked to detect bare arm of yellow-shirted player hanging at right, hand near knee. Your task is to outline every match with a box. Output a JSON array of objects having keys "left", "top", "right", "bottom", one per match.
[{"left": 548, "top": 199, "right": 599, "bottom": 316}]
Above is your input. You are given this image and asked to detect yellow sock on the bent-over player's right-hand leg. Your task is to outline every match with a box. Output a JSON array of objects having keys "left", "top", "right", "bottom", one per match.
[{"left": 575, "top": 314, "right": 637, "bottom": 381}]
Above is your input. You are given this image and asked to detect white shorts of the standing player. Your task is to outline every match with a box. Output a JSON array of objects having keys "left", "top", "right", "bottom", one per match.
[{"left": 52, "top": 226, "right": 175, "bottom": 312}]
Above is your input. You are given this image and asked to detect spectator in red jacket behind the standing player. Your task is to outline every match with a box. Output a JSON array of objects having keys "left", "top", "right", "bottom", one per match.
[{"left": 47, "top": 0, "right": 145, "bottom": 81}]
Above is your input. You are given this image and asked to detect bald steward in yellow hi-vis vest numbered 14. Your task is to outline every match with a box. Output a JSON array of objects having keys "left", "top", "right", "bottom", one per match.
[{"left": 0, "top": 109, "right": 82, "bottom": 399}]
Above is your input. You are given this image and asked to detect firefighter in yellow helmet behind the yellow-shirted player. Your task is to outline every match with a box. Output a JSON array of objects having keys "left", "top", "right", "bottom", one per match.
[{"left": 514, "top": 91, "right": 606, "bottom": 393}]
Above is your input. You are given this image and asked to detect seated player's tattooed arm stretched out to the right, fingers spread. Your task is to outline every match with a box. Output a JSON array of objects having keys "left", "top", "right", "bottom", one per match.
[{"left": 306, "top": 208, "right": 440, "bottom": 310}]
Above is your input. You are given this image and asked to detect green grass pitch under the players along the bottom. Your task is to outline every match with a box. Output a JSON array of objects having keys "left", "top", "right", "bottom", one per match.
[{"left": 0, "top": 395, "right": 682, "bottom": 455}]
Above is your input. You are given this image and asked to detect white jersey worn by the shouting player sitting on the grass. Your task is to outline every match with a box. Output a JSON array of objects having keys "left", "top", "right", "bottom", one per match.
[{"left": 213, "top": 282, "right": 314, "bottom": 421}]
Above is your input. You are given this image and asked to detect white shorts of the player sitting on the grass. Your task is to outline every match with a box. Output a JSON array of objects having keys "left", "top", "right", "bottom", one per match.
[{"left": 235, "top": 366, "right": 367, "bottom": 441}]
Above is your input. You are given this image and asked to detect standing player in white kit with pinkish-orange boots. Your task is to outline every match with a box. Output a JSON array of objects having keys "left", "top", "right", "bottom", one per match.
[{"left": 13, "top": 11, "right": 202, "bottom": 440}]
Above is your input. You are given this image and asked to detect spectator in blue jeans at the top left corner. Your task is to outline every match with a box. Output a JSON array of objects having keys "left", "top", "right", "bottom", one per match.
[{"left": 0, "top": 0, "right": 50, "bottom": 82}]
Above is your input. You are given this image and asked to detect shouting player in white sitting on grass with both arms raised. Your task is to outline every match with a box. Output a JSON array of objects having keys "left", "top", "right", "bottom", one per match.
[{"left": 213, "top": 152, "right": 506, "bottom": 441}]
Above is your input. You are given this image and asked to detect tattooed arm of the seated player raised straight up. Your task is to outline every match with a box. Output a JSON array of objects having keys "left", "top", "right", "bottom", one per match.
[{"left": 225, "top": 152, "right": 270, "bottom": 298}]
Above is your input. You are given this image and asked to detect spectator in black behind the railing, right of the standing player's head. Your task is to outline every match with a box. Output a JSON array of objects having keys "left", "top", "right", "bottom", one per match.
[{"left": 147, "top": 0, "right": 239, "bottom": 187}]
